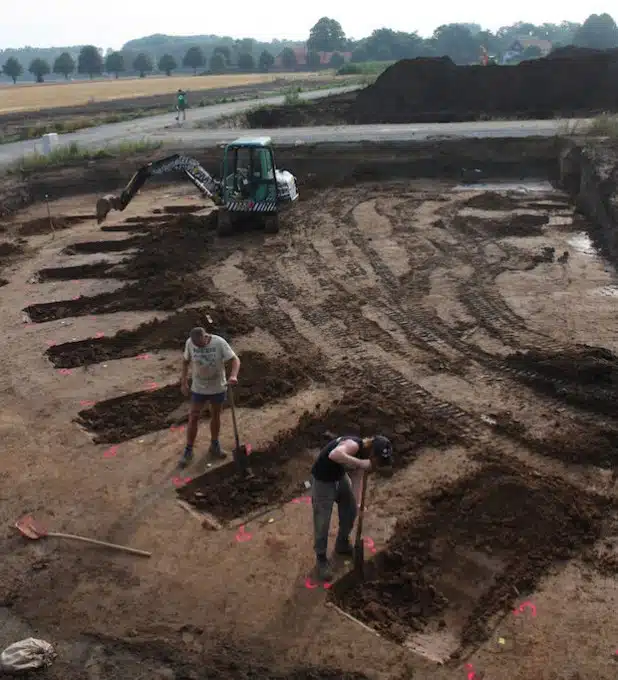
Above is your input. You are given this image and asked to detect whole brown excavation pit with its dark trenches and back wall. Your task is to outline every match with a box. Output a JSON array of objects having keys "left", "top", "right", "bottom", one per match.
[{"left": 0, "top": 140, "right": 618, "bottom": 680}]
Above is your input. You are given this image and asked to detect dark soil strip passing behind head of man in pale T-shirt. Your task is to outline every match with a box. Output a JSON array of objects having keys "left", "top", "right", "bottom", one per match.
[{"left": 46, "top": 307, "right": 255, "bottom": 368}]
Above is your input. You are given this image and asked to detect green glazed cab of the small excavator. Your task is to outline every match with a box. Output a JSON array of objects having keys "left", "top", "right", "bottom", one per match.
[{"left": 222, "top": 137, "right": 277, "bottom": 205}]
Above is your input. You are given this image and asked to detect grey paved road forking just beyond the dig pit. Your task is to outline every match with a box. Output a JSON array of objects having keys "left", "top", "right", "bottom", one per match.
[{"left": 0, "top": 86, "right": 587, "bottom": 166}]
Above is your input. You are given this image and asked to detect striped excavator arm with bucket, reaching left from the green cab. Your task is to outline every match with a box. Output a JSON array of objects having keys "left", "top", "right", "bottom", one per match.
[{"left": 97, "top": 154, "right": 221, "bottom": 224}]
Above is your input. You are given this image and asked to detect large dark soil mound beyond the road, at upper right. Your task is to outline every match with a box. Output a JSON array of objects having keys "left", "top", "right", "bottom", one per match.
[{"left": 350, "top": 49, "right": 618, "bottom": 123}]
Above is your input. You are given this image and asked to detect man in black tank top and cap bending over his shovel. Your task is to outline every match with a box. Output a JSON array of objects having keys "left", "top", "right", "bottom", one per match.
[{"left": 311, "top": 435, "right": 393, "bottom": 581}]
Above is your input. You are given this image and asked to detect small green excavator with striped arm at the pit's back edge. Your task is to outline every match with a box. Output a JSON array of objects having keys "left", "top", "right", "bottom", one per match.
[{"left": 96, "top": 137, "right": 298, "bottom": 235}]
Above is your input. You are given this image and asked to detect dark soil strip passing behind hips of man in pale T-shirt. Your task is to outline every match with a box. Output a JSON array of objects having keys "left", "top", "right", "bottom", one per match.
[{"left": 78, "top": 354, "right": 310, "bottom": 443}]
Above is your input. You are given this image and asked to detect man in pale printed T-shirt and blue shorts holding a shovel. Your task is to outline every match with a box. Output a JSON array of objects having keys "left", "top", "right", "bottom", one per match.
[{"left": 180, "top": 328, "right": 240, "bottom": 467}]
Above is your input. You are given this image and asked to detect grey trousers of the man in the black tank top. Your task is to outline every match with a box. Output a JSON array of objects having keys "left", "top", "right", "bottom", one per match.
[{"left": 311, "top": 474, "right": 356, "bottom": 558}]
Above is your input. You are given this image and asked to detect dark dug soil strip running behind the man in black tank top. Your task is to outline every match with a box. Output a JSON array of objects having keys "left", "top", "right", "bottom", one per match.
[{"left": 178, "top": 390, "right": 458, "bottom": 522}]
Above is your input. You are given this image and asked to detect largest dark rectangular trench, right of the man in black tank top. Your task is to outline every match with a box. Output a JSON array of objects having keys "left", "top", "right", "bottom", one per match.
[{"left": 331, "top": 464, "right": 609, "bottom": 662}]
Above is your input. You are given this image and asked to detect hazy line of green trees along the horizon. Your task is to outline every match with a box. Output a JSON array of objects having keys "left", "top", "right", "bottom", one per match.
[{"left": 0, "top": 14, "right": 618, "bottom": 83}]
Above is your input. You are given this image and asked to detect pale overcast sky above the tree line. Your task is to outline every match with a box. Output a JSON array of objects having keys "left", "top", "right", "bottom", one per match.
[{"left": 0, "top": 0, "right": 618, "bottom": 49}]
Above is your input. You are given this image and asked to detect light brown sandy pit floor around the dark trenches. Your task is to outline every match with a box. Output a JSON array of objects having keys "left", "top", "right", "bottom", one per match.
[{"left": 0, "top": 181, "right": 618, "bottom": 680}]
